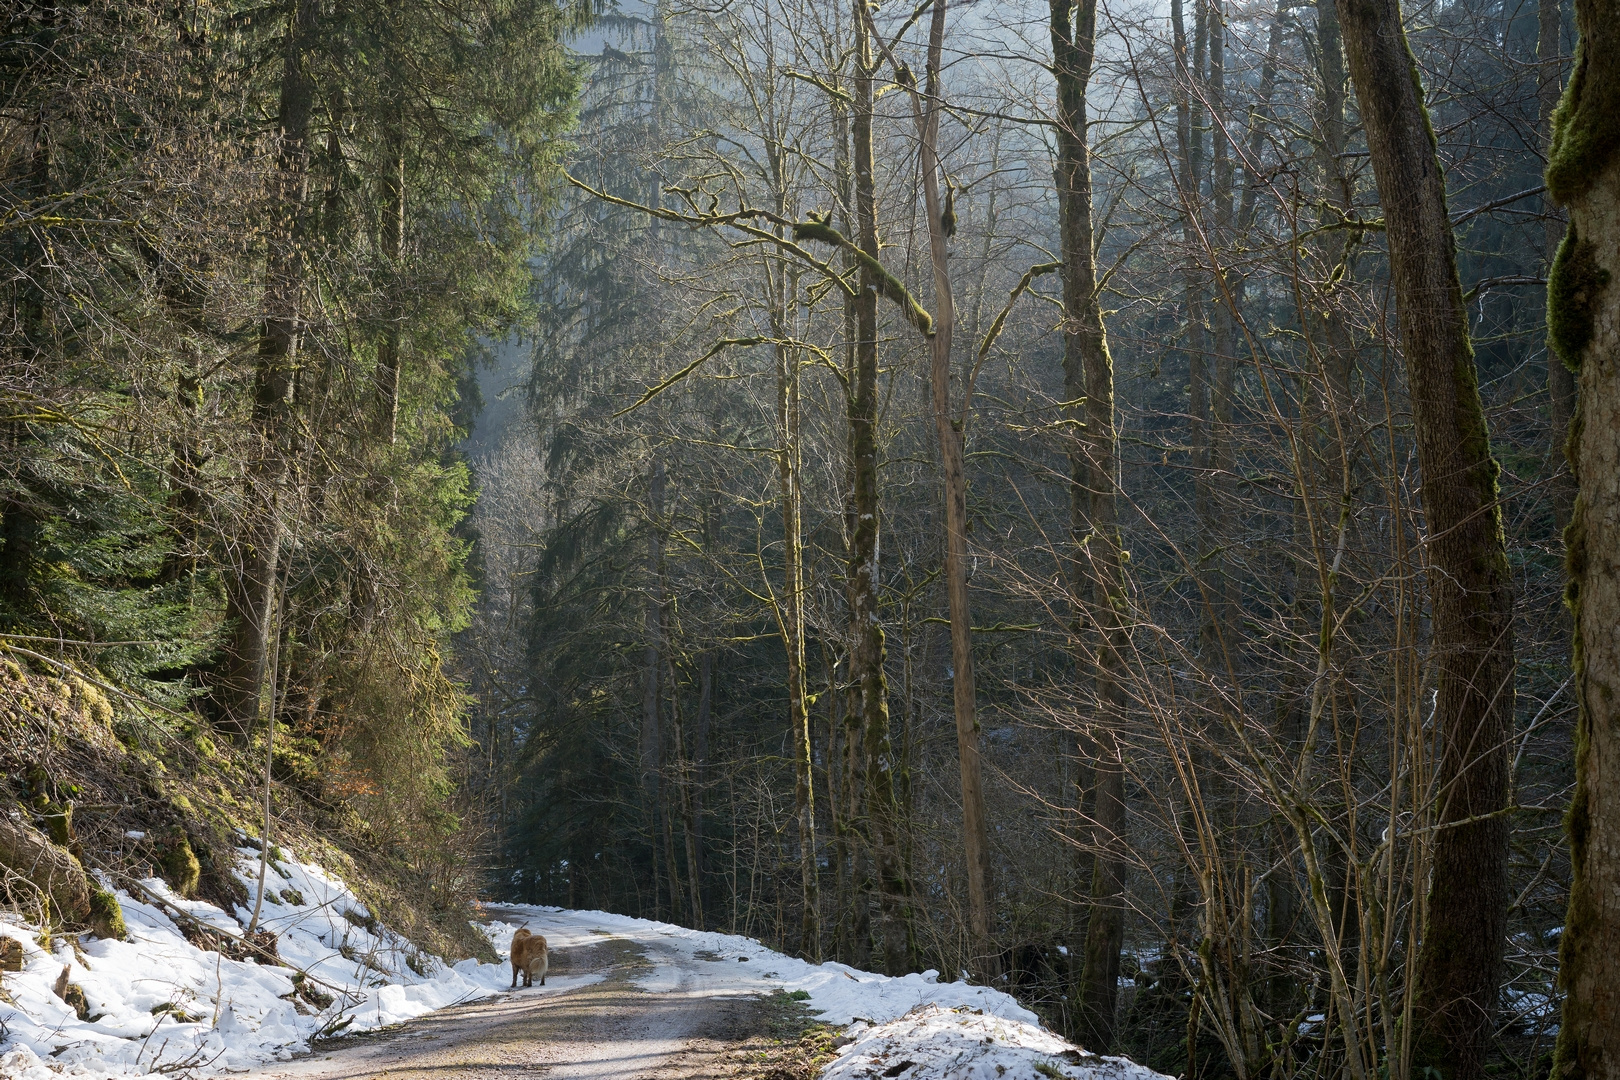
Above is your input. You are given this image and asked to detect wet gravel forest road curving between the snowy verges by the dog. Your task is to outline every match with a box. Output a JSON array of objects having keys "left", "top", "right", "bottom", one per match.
[{"left": 248, "top": 907, "right": 760, "bottom": 1080}]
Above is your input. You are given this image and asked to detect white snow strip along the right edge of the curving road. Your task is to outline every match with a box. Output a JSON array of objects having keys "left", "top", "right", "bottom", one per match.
[{"left": 486, "top": 905, "right": 1163, "bottom": 1080}]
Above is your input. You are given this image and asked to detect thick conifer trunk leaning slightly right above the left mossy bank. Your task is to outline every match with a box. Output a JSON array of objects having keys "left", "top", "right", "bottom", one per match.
[{"left": 215, "top": 0, "right": 319, "bottom": 735}]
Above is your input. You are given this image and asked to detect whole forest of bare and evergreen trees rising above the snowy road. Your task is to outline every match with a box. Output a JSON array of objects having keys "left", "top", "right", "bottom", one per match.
[{"left": 0, "top": 0, "right": 1620, "bottom": 1080}]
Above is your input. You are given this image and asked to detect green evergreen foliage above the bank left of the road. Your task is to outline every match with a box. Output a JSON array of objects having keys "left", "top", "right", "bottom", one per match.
[{"left": 0, "top": 0, "right": 590, "bottom": 894}]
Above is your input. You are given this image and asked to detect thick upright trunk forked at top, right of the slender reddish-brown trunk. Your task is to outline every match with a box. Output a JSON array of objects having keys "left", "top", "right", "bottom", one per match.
[{"left": 1050, "top": 0, "right": 1126, "bottom": 1052}]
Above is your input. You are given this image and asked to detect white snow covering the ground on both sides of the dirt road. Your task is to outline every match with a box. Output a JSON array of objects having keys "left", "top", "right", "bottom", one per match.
[{"left": 0, "top": 848, "right": 1158, "bottom": 1080}]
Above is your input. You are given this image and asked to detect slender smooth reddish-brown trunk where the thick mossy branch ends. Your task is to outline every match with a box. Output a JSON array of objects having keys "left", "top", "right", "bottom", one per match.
[{"left": 912, "top": 0, "right": 1000, "bottom": 980}]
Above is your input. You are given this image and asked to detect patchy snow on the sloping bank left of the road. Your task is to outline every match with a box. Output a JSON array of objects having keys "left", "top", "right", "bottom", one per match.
[{"left": 0, "top": 848, "right": 595, "bottom": 1080}]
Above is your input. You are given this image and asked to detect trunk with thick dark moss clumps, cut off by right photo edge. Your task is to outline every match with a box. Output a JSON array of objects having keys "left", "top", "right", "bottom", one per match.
[{"left": 1547, "top": 0, "right": 1620, "bottom": 1080}]
